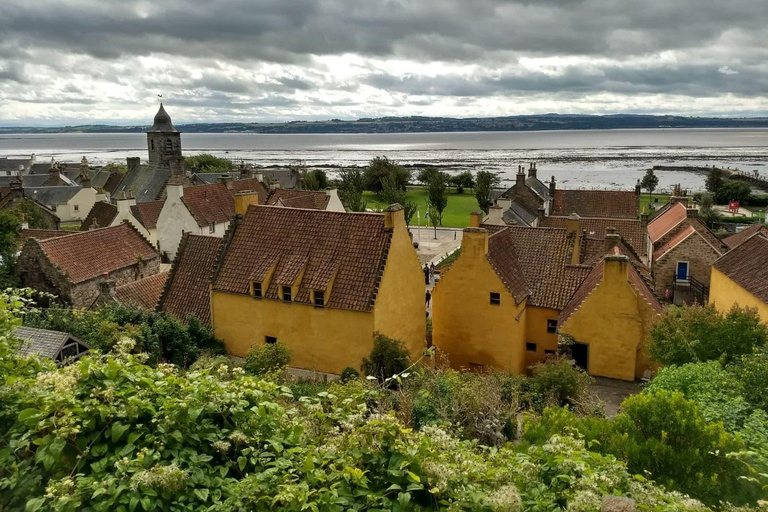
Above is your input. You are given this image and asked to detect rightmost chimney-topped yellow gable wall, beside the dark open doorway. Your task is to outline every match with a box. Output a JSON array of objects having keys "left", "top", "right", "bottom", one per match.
[{"left": 560, "top": 259, "right": 657, "bottom": 380}]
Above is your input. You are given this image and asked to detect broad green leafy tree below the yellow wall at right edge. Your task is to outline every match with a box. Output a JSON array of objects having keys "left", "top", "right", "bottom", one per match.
[{"left": 648, "top": 304, "right": 768, "bottom": 365}]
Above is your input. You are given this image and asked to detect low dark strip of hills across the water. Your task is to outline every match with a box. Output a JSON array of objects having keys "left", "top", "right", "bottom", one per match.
[{"left": 0, "top": 114, "right": 768, "bottom": 134}]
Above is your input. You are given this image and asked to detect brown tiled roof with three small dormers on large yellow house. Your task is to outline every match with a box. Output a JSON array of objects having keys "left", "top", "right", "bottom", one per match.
[{"left": 214, "top": 205, "right": 392, "bottom": 311}]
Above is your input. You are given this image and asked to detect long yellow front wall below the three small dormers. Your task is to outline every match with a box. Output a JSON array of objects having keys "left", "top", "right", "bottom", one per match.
[{"left": 211, "top": 291, "right": 374, "bottom": 374}]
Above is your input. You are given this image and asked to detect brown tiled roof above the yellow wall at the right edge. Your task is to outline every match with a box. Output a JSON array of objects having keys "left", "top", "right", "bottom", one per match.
[{"left": 712, "top": 233, "right": 768, "bottom": 303}]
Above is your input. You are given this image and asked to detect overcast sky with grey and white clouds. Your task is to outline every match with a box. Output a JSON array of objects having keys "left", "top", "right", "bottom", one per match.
[{"left": 0, "top": 0, "right": 768, "bottom": 125}]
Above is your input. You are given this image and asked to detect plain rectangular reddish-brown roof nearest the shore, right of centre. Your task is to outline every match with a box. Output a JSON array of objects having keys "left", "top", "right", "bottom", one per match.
[{"left": 549, "top": 190, "right": 638, "bottom": 219}]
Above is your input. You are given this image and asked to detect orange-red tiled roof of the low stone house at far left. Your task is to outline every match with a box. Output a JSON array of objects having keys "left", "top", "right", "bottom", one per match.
[{"left": 39, "top": 223, "right": 158, "bottom": 283}]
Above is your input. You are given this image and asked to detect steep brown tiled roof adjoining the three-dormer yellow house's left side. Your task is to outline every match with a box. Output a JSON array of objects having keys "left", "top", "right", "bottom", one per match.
[{"left": 157, "top": 233, "right": 222, "bottom": 325}]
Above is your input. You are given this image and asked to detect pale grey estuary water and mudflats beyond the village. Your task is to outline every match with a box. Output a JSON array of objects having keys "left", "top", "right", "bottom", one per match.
[{"left": 0, "top": 128, "right": 768, "bottom": 190}]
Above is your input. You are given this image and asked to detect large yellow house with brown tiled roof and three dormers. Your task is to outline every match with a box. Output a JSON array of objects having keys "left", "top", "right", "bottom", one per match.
[{"left": 211, "top": 205, "right": 426, "bottom": 374}]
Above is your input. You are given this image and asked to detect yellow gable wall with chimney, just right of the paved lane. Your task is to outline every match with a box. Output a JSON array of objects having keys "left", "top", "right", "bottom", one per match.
[{"left": 432, "top": 230, "right": 526, "bottom": 373}]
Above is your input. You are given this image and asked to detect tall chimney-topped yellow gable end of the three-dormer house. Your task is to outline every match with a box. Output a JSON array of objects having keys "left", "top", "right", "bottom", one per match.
[{"left": 372, "top": 210, "right": 427, "bottom": 366}]
